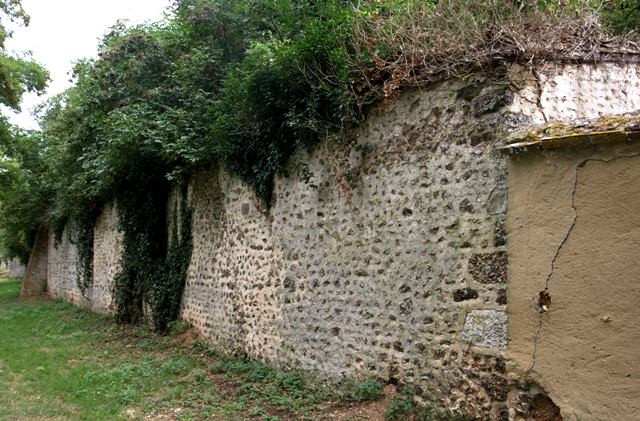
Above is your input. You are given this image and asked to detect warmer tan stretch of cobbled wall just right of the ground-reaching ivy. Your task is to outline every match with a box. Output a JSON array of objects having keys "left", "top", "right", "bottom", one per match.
[{"left": 182, "top": 169, "right": 282, "bottom": 362}]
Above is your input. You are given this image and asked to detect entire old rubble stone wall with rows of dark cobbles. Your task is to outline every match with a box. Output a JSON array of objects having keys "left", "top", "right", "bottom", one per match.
[{"left": 43, "top": 60, "right": 640, "bottom": 420}]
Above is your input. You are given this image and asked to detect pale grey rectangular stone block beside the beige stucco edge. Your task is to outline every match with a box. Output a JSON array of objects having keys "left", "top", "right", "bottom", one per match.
[{"left": 462, "top": 310, "right": 507, "bottom": 349}]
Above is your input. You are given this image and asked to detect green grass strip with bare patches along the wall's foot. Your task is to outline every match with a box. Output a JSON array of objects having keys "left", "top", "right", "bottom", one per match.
[{"left": 0, "top": 280, "right": 408, "bottom": 421}]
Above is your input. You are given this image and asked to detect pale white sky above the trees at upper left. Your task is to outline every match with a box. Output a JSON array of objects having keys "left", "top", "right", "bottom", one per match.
[{"left": 4, "top": 0, "right": 171, "bottom": 129}]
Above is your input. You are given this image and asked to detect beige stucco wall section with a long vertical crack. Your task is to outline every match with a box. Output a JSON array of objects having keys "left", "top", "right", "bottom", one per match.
[{"left": 507, "top": 144, "right": 640, "bottom": 421}]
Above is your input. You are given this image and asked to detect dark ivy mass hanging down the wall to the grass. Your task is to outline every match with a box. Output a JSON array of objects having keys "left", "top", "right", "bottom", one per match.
[{"left": 113, "top": 161, "right": 192, "bottom": 332}]
